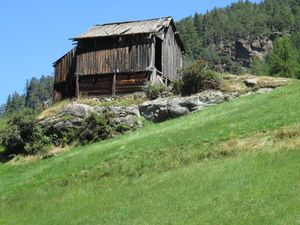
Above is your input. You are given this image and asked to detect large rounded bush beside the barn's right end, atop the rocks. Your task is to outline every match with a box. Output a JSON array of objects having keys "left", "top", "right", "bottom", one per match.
[{"left": 181, "top": 60, "right": 221, "bottom": 95}]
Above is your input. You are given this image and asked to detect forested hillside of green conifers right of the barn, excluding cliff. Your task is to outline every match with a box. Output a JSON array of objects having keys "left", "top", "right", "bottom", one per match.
[{"left": 177, "top": 0, "right": 300, "bottom": 78}]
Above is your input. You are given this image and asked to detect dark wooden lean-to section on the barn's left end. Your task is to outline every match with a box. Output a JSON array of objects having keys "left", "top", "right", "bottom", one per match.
[{"left": 53, "top": 48, "right": 76, "bottom": 102}]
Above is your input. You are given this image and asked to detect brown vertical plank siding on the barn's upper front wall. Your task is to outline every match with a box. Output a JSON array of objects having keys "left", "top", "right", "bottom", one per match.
[{"left": 76, "top": 35, "right": 151, "bottom": 75}]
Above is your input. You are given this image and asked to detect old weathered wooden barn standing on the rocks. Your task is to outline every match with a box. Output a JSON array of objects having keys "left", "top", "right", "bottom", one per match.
[{"left": 53, "top": 17, "right": 185, "bottom": 102}]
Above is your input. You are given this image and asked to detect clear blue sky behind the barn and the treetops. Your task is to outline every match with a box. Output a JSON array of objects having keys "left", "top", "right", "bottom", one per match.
[{"left": 0, "top": 0, "right": 260, "bottom": 104}]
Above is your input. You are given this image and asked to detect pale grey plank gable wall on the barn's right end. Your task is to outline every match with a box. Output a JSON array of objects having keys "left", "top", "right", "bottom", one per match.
[{"left": 162, "top": 26, "right": 183, "bottom": 81}]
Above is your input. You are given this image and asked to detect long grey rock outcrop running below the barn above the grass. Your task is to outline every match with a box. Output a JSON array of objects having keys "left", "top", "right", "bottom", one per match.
[{"left": 39, "top": 75, "right": 288, "bottom": 129}]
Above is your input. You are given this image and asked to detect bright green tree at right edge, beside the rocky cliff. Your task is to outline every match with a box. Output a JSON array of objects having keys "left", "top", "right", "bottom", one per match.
[{"left": 270, "top": 37, "right": 300, "bottom": 78}]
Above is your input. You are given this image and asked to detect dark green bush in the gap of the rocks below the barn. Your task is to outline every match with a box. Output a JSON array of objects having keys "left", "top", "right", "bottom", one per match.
[{"left": 79, "top": 113, "right": 111, "bottom": 144}]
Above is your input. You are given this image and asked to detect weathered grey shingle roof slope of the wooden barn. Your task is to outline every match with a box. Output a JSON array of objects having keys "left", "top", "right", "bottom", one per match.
[{"left": 72, "top": 17, "right": 172, "bottom": 40}]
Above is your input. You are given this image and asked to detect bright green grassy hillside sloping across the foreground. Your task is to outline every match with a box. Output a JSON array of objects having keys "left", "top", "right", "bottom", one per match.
[{"left": 0, "top": 82, "right": 300, "bottom": 224}]
